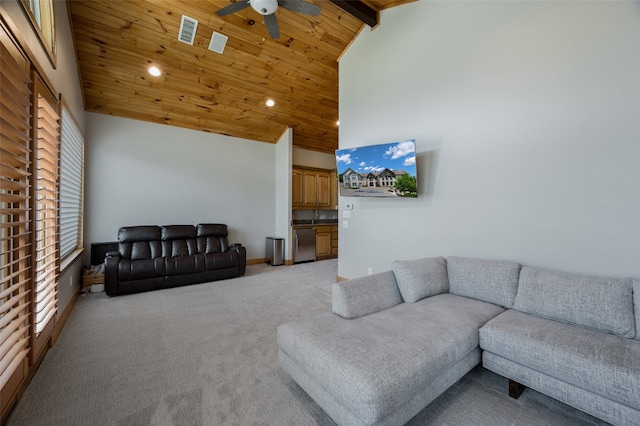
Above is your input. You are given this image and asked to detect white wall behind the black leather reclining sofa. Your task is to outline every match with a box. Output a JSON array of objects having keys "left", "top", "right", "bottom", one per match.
[{"left": 85, "top": 113, "right": 276, "bottom": 259}]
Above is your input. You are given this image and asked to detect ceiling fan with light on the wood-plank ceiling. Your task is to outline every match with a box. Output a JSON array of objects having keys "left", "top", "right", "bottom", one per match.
[{"left": 216, "top": 0, "right": 320, "bottom": 38}]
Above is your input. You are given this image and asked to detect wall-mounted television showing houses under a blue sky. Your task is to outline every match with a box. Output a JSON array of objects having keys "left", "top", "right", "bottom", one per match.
[{"left": 336, "top": 139, "right": 418, "bottom": 198}]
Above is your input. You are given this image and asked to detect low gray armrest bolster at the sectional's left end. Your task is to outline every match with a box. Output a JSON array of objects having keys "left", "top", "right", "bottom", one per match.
[{"left": 332, "top": 271, "right": 402, "bottom": 319}]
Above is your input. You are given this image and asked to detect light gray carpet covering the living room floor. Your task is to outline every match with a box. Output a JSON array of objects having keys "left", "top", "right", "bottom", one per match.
[{"left": 8, "top": 260, "right": 604, "bottom": 426}]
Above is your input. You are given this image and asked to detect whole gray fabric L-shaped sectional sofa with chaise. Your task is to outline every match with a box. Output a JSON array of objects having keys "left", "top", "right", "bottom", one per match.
[{"left": 277, "top": 257, "right": 640, "bottom": 425}]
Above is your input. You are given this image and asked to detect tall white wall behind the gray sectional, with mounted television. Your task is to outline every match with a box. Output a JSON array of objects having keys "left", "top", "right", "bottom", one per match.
[{"left": 339, "top": 1, "right": 640, "bottom": 278}]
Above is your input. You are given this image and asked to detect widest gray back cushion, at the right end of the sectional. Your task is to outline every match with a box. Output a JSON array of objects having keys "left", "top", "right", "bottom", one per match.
[{"left": 514, "top": 266, "right": 636, "bottom": 338}]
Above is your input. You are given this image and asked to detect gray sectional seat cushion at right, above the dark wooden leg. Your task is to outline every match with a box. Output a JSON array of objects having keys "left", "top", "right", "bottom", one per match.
[{"left": 480, "top": 310, "right": 640, "bottom": 410}]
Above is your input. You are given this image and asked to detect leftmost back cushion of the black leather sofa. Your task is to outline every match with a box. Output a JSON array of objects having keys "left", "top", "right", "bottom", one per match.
[{"left": 118, "top": 226, "right": 162, "bottom": 260}]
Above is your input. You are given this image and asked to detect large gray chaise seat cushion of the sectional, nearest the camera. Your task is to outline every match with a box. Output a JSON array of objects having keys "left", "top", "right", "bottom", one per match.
[{"left": 278, "top": 294, "right": 504, "bottom": 424}]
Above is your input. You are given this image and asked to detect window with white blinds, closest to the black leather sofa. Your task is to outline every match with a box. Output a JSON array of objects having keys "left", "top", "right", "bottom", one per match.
[{"left": 60, "top": 104, "right": 84, "bottom": 258}]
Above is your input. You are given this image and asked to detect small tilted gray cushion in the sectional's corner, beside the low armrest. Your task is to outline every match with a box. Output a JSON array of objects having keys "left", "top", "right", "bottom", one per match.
[{"left": 391, "top": 257, "right": 449, "bottom": 303}]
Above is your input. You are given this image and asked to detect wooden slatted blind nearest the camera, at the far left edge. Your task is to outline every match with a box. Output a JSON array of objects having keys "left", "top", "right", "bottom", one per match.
[{"left": 0, "top": 24, "right": 32, "bottom": 406}]
